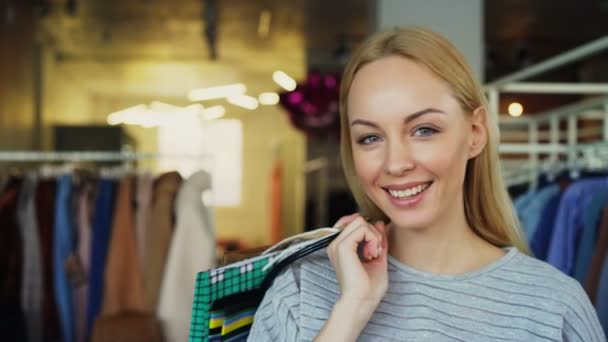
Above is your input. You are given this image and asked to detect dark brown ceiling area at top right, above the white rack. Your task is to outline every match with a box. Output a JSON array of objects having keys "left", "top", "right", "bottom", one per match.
[{"left": 484, "top": 0, "right": 608, "bottom": 81}]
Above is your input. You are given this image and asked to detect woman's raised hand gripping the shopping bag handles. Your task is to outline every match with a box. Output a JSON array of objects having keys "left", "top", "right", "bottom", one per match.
[{"left": 327, "top": 214, "right": 388, "bottom": 312}]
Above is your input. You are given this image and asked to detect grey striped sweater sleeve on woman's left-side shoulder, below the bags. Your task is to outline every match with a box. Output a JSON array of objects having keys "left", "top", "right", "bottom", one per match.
[{"left": 247, "top": 265, "right": 300, "bottom": 342}]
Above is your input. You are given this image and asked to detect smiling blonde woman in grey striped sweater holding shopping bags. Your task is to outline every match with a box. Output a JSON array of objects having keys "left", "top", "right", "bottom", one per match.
[{"left": 249, "top": 28, "right": 606, "bottom": 342}]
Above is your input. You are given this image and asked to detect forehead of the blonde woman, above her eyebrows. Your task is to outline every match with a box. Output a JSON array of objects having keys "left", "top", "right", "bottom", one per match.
[{"left": 347, "top": 56, "right": 457, "bottom": 120}]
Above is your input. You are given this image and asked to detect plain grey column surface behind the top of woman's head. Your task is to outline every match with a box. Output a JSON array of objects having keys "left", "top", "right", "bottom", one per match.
[{"left": 375, "top": 0, "right": 484, "bottom": 82}]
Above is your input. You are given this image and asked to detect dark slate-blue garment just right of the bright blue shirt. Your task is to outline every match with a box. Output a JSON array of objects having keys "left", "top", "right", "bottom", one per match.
[{"left": 574, "top": 190, "right": 608, "bottom": 284}]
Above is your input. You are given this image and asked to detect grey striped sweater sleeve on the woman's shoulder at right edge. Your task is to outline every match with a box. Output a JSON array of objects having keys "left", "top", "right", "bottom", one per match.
[{"left": 562, "top": 280, "right": 606, "bottom": 342}]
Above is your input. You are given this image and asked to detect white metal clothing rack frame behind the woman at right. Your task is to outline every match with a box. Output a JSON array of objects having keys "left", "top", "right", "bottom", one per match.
[{"left": 484, "top": 36, "right": 608, "bottom": 187}]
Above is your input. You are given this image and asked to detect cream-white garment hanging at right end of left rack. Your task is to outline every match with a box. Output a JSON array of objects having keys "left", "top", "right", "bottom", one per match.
[{"left": 158, "top": 171, "right": 216, "bottom": 341}]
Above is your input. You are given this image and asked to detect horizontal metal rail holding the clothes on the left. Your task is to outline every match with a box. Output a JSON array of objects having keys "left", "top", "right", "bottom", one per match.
[{"left": 0, "top": 151, "right": 211, "bottom": 162}]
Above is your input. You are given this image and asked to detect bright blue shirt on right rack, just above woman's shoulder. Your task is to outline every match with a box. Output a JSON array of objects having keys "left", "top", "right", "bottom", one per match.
[{"left": 547, "top": 178, "right": 608, "bottom": 275}]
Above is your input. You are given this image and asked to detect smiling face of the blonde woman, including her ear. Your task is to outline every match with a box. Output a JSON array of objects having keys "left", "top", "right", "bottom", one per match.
[{"left": 347, "top": 56, "right": 486, "bottom": 229}]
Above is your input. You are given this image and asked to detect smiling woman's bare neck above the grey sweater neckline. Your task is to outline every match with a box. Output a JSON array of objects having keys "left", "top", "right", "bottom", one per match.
[{"left": 389, "top": 200, "right": 504, "bottom": 275}]
